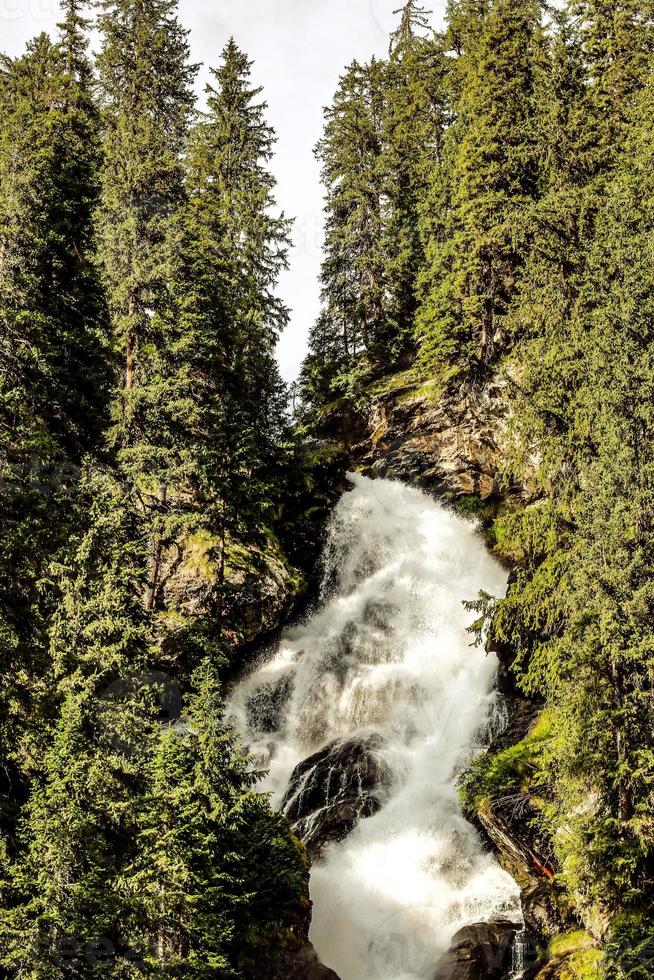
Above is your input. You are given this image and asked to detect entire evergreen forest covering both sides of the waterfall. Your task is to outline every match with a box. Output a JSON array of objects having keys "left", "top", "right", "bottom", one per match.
[{"left": 0, "top": 0, "right": 654, "bottom": 980}]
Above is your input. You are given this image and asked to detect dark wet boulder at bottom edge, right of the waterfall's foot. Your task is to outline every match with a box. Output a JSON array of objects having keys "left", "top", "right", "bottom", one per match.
[{"left": 433, "top": 919, "right": 522, "bottom": 980}]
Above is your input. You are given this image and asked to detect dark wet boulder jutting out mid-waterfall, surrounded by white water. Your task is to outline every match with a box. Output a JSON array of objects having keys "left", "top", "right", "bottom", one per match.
[{"left": 282, "top": 735, "right": 392, "bottom": 859}]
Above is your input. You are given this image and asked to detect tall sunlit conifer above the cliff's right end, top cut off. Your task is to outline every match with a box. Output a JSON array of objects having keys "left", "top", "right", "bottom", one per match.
[{"left": 418, "top": 0, "right": 542, "bottom": 370}]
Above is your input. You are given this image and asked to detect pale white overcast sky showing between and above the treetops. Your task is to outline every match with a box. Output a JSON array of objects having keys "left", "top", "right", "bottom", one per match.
[{"left": 0, "top": 0, "right": 445, "bottom": 381}]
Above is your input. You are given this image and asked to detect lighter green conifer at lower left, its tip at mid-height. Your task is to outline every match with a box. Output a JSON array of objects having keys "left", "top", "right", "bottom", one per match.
[{"left": 0, "top": 467, "right": 151, "bottom": 976}]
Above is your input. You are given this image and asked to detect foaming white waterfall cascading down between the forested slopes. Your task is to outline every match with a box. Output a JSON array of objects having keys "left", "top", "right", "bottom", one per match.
[{"left": 231, "top": 475, "right": 520, "bottom": 980}]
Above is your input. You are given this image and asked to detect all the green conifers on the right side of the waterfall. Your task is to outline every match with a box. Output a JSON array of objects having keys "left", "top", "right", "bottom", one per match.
[{"left": 303, "top": 0, "right": 654, "bottom": 952}]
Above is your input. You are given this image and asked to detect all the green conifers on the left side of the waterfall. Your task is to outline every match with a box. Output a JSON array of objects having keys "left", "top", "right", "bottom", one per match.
[{"left": 0, "top": 0, "right": 309, "bottom": 978}]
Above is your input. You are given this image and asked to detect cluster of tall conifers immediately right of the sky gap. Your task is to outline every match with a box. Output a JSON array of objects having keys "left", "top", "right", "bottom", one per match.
[{"left": 301, "top": 2, "right": 447, "bottom": 408}]
